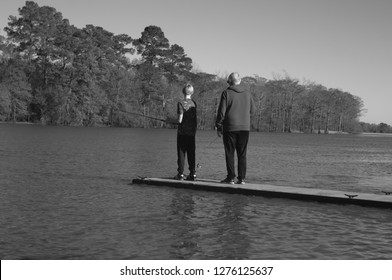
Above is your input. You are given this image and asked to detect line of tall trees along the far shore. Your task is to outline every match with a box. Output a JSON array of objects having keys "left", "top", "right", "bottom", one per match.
[{"left": 0, "top": 1, "right": 388, "bottom": 133}]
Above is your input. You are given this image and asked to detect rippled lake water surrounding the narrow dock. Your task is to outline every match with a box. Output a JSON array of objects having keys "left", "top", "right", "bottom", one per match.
[{"left": 0, "top": 124, "right": 392, "bottom": 259}]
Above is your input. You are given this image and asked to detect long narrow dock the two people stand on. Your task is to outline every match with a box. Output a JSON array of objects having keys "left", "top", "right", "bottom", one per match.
[{"left": 132, "top": 178, "right": 392, "bottom": 208}]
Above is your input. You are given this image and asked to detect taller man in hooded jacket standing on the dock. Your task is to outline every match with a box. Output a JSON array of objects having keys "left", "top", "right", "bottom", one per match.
[{"left": 215, "top": 72, "right": 254, "bottom": 184}]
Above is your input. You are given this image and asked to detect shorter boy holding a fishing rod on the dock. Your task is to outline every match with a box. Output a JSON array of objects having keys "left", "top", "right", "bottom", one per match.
[{"left": 174, "top": 84, "right": 197, "bottom": 181}]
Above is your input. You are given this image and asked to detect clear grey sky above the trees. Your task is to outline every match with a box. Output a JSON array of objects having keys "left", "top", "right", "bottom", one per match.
[{"left": 0, "top": 0, "right": 392, "bottom": 125}]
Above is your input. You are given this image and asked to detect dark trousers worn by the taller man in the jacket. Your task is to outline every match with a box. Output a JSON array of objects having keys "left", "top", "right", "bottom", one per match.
[{"left": 223, "top": 130, "right": 249, "bottom": 179}]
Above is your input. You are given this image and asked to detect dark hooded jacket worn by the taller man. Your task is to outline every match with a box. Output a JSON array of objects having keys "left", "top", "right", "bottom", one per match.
[{"left": 215, "top": 85, "right": 254, "bottom": 131}]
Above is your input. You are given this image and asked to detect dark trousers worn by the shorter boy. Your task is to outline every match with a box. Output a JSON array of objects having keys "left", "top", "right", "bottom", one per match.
[{"left": 177, "top": 135, "right": 196, "bottom": 174}]
